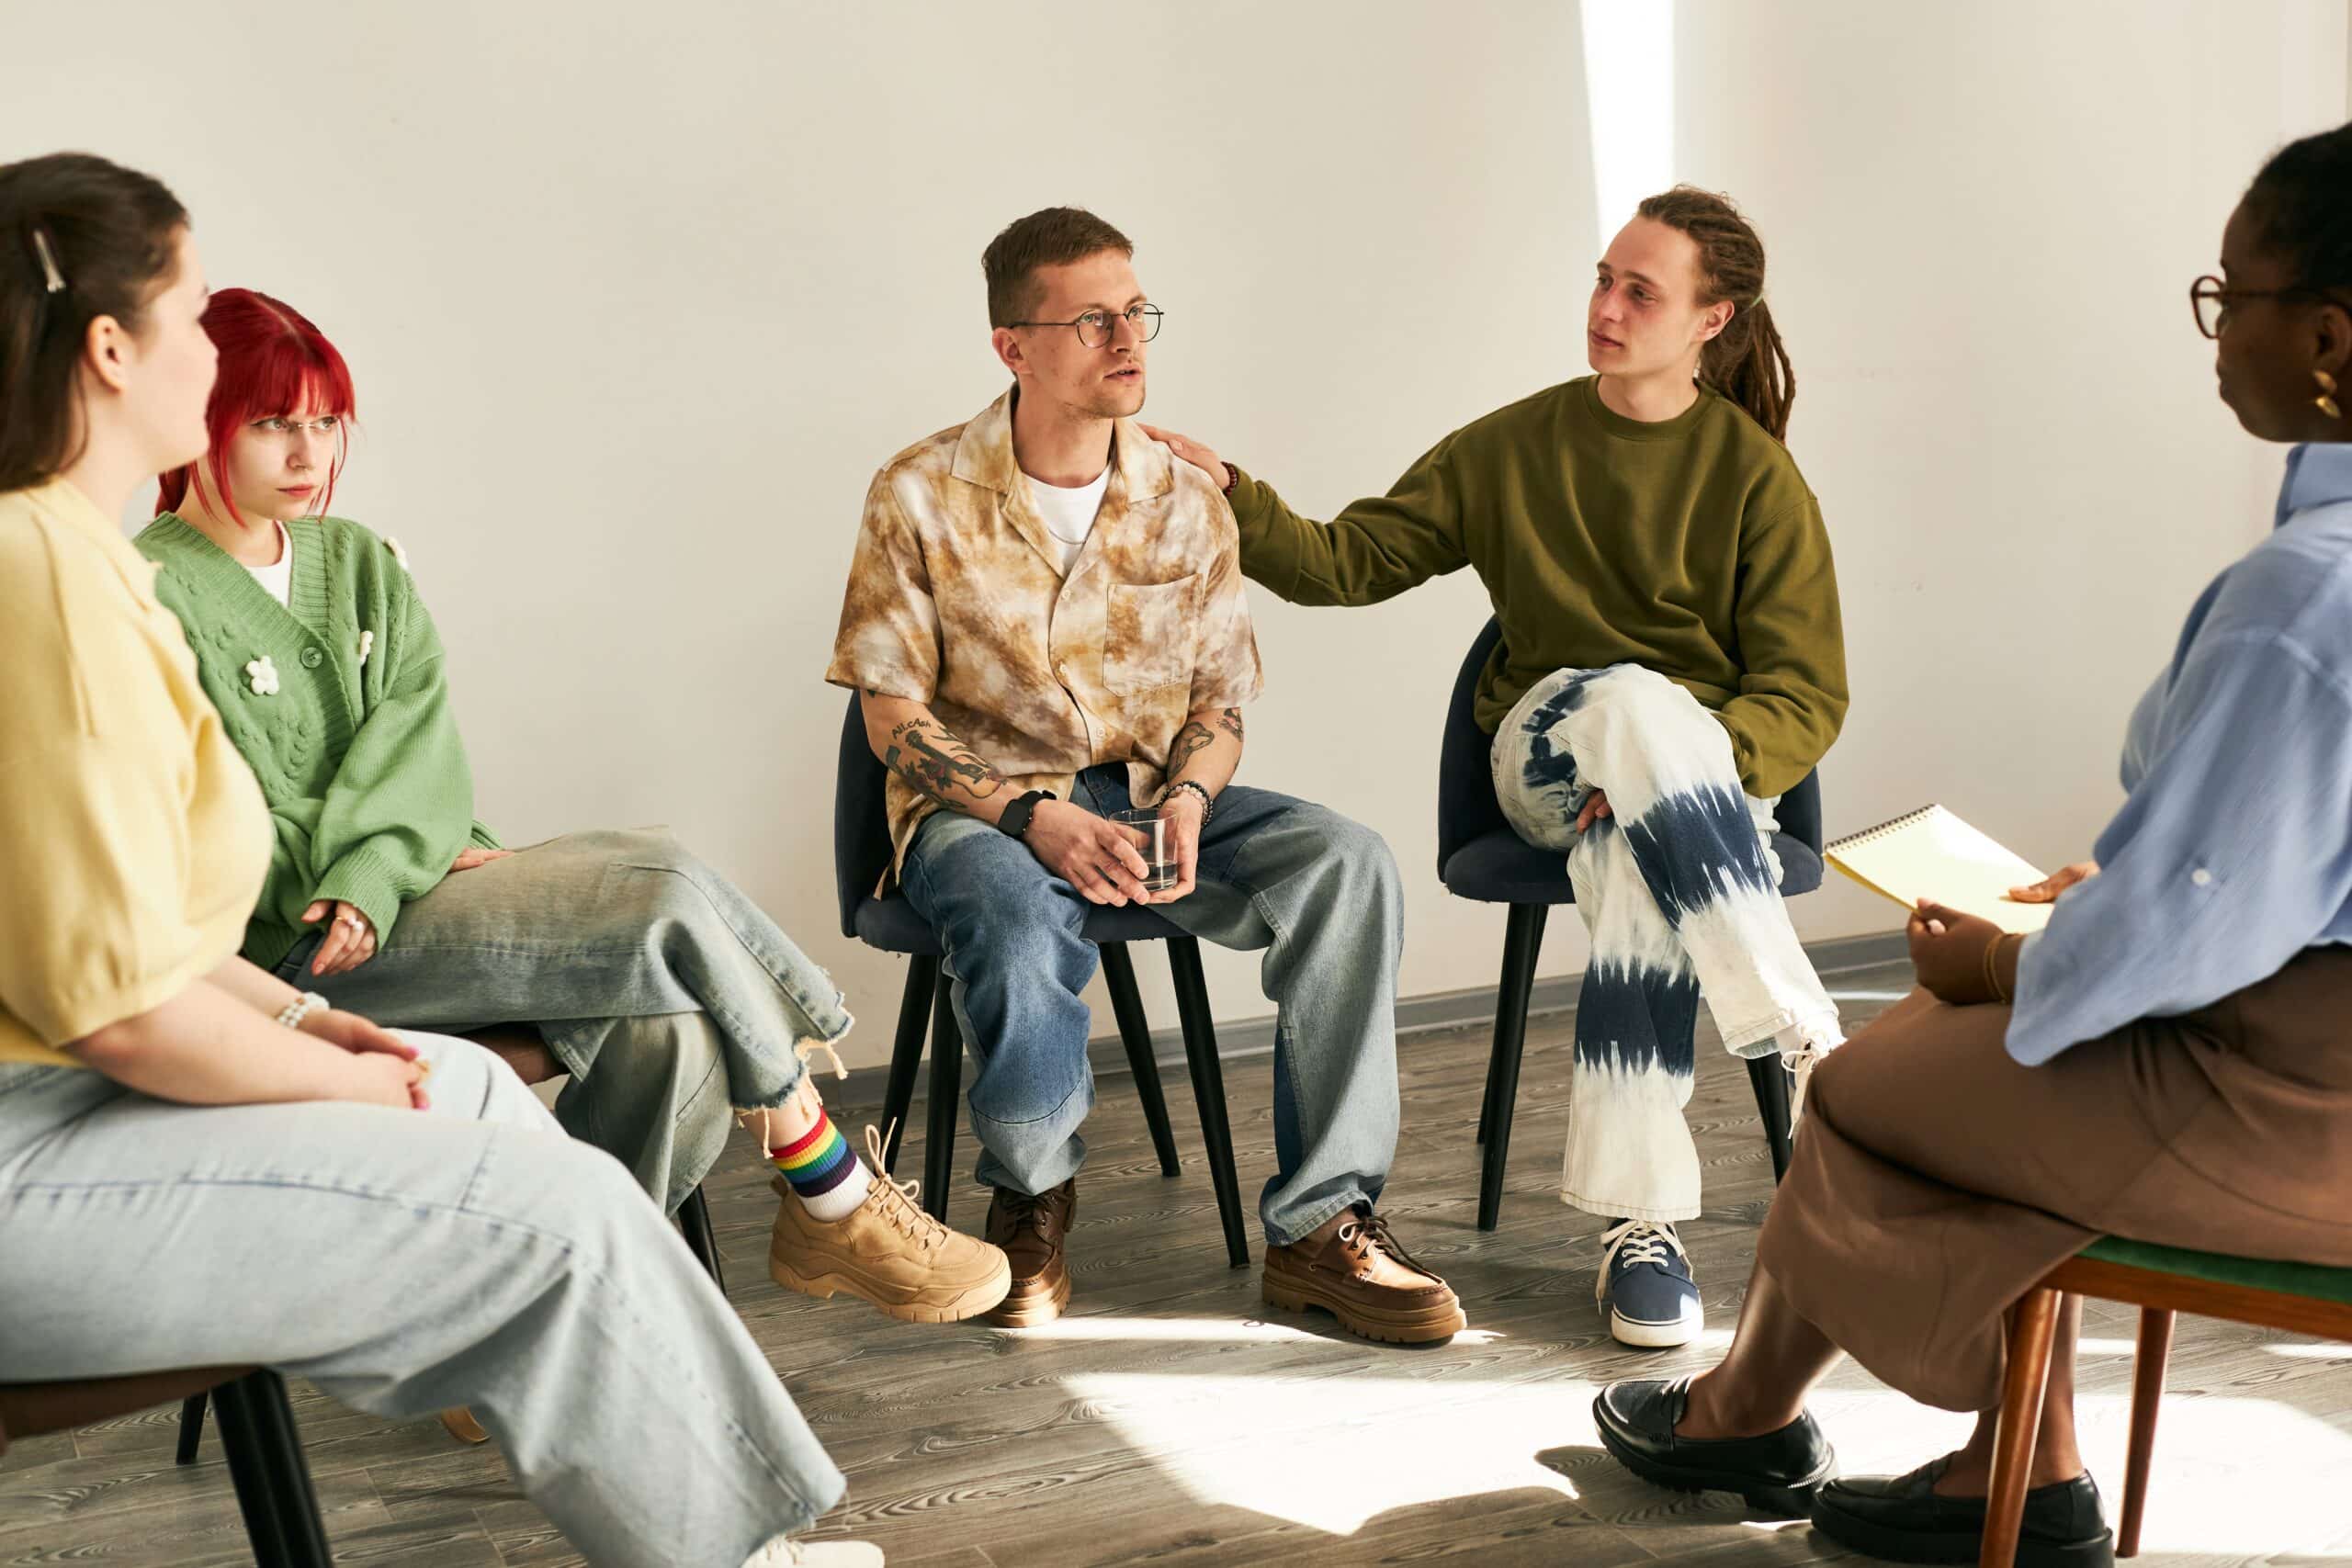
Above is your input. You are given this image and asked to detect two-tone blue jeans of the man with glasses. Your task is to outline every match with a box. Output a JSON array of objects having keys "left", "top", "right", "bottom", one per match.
[{"left": 900, "top": 764, "right": 1404, "bottom": 1246}]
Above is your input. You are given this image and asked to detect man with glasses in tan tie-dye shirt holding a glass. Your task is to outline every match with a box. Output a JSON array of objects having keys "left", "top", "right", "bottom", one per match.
[{"left": 826, "top": 207, "right": 1463, "bottom": 1342}]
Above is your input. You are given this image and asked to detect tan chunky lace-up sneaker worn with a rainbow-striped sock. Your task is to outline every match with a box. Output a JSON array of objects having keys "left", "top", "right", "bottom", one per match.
[{"left": 767, "top": 1126, "right": 1013, "bottom": 1324}]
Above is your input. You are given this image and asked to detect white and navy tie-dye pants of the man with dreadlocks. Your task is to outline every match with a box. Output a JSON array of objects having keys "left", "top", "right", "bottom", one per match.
[{"left": 1494, "top": 665, "right": 1841, "bottom": 1220}]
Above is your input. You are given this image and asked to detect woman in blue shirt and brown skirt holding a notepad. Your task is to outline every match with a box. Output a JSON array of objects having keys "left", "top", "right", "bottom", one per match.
[{"left": 1595, "top": 125, "right": 2352, "bottom": 1568}]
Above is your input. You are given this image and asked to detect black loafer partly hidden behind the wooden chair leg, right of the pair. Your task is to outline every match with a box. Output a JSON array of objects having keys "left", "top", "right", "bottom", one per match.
[{"left": 1814, "top": 1455, "right": 2114, "bottom": 1568}]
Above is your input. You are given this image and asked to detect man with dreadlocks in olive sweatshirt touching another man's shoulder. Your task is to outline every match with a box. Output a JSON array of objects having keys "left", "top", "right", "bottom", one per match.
[{"left": 1152, "top": 186, "right": 1847, "bottom": 1347}]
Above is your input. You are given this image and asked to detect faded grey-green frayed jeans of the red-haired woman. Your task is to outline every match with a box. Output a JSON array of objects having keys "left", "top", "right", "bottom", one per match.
[{"left": 277, "top": 829, "right": 849, "bottom": 1213}]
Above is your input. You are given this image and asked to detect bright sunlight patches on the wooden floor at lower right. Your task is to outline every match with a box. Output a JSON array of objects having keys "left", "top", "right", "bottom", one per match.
[{"left": 1066, "top": 1372, "right": 2352, "bottom": 1554}]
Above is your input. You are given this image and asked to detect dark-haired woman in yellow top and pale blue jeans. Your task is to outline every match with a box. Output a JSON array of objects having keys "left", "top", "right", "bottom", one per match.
[{"left": 0, "top": 155, "right": 882, "bottom": 1565}]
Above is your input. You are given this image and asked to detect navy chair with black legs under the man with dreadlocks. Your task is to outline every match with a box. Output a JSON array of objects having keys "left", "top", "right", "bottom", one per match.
[{"left": 1437, "top": 621, "right": 1820, "bottom": 1229}]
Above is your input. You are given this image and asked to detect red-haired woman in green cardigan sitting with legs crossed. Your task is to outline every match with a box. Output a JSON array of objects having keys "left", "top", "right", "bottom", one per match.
[{"left": 136, "top": 289, "right": 1012, "bottom": 1321}]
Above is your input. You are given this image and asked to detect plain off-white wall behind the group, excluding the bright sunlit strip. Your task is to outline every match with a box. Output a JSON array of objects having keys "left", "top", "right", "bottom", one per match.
[{"left": 0, "top": 0, "right": 2345, "bottom": 1060}]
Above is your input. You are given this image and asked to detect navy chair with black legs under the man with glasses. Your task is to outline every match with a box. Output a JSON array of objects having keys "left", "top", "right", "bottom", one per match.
[{"left": 832, "top": 694, "right": 1249, "bottom": 1269}]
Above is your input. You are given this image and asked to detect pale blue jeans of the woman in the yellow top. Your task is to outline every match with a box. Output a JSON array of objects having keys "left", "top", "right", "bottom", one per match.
[{"left": 0, "top": 1034, "right": 842, "bottom": 1568}]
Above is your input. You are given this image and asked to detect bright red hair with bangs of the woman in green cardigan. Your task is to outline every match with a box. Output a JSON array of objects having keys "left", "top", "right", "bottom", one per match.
[{"left": 155, "top": 289, "right": 357, "bottom": 526}]
